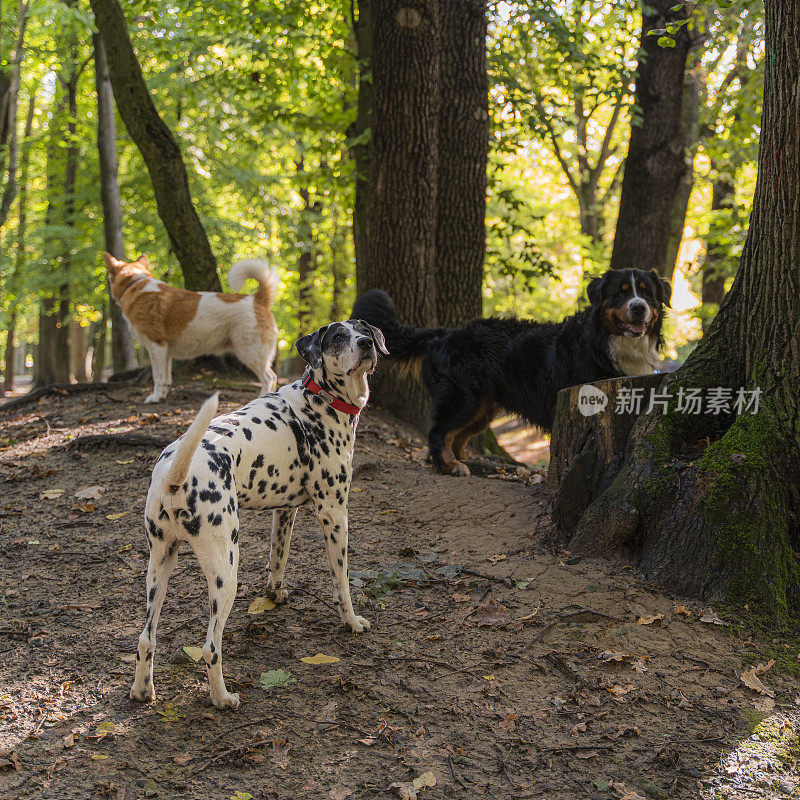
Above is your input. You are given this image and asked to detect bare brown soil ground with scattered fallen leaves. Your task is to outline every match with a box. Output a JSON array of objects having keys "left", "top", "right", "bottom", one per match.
[{"left": 0, "top": 381, "right": 800, "bottom": 800}]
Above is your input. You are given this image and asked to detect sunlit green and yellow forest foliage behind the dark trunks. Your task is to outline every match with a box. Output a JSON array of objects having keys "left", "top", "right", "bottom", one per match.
[{"left": 0, "top": 0, "right": 764, "bottom": 388}]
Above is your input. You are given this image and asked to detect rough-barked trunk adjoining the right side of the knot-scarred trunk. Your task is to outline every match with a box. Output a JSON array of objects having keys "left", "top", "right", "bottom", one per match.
[{"left": 436, "top": 0, "right": 489, "bottom": 328}]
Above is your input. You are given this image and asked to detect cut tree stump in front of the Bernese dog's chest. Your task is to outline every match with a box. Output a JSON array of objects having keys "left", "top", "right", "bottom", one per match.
[{"left": 547, "top": 374, "right": 664, "bottom": 533}]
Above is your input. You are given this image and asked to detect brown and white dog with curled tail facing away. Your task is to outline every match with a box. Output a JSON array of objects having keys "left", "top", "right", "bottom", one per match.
[{"left": 103, "top": 253, "right": 280, "bottom": 403}]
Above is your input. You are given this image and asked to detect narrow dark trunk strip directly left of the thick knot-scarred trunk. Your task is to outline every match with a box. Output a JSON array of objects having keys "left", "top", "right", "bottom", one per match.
[{"left": 348, "top": 0, "right": 372, "bottom": 286}]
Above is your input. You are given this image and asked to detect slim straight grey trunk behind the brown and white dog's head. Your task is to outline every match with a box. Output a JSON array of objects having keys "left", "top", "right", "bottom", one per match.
[{"left": 92, "top": 33, "right": 136, "bottom": 368}]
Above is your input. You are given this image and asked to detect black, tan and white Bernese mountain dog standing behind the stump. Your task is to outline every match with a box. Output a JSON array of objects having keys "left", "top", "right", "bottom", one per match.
[{"left": 353, "top": 269, "right": 671, "bottom": 475}]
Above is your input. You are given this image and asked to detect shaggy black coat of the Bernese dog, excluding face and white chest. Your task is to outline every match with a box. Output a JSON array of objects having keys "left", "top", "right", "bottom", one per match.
[{"left": 353, "top": 273, "right": 663, "bottom": 474}]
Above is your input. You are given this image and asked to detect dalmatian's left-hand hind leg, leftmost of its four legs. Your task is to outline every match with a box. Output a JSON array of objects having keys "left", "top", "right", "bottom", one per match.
[{"left": 130, "top": 529, "right": 180, "bottom": 703}]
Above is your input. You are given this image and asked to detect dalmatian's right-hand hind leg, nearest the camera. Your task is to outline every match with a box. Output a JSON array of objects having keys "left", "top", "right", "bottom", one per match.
[{"left": 191, "top": 528, "right": 239, "bottom": 708}]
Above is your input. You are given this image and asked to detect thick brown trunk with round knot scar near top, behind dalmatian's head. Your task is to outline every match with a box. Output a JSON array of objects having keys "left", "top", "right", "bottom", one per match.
[{"left": 357, "top": 0, "right": 440, "bottom": 426}]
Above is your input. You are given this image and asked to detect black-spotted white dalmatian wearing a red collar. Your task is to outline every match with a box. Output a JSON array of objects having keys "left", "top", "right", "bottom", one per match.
[{"left": 130, "top": 320, "right": 388, "bottom": 708}]
